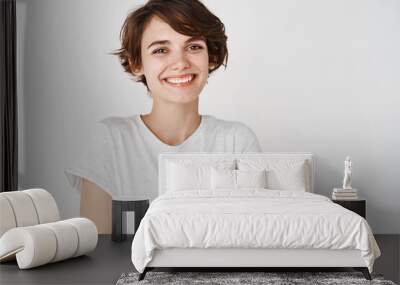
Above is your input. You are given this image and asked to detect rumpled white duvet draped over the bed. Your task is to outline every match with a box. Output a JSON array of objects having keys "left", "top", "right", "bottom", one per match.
[{"left": 132, "top": 189, "right": 380, "bottom": 272}]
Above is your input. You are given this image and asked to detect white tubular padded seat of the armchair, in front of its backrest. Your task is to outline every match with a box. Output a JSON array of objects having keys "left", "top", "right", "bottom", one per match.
[{"left": 0, "top": 218, "right": 98, "bottom": 269}]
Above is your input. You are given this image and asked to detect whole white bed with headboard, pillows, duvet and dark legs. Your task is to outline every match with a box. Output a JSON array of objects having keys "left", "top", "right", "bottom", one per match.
[{"left": 131, "top": 153, "right": 380, "bottom": 280}]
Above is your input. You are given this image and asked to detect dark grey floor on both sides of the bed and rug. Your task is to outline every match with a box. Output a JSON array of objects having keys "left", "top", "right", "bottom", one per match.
[{"left": 0, "top": 235, "right": 400, "bottom": 285}]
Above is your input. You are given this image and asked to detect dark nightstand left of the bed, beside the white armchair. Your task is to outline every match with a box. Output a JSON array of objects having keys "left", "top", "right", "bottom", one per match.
[{"left": 111, "top": 197, "right": 150, "bottom": 241}]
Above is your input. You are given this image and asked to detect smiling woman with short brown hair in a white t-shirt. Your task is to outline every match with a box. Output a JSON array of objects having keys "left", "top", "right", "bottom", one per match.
[{"left": 66, "top": 0, "right": 261, "bottom": 233}]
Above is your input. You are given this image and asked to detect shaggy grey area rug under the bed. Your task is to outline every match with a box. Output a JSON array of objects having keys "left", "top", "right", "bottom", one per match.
[{"left": 117, "top": 271, "right": 395, "bottom": 285}]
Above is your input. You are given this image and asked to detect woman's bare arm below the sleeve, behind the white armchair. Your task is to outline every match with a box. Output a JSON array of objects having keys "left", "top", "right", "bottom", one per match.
[{"left": 80, "top": 179, "right": 112, "bottom": 234}]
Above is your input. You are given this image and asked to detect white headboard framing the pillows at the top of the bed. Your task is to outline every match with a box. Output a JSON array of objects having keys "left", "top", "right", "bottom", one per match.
[{"left": 158, "top": 152, "right": 315, "bottom": 195}]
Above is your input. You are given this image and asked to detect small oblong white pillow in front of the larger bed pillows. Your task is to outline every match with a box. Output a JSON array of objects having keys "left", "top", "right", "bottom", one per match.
[{"left": 211, "top": 168, "right": 267, "bottom": 190}]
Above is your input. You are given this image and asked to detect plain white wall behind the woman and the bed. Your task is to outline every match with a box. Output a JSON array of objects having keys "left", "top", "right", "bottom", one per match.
[{"left": 17, "top": 0, "right": 400, "bottom": 233}]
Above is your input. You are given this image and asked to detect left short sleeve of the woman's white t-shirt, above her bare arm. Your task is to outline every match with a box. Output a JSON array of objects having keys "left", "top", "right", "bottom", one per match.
[{"left": 65, "top": 120, "right": 116, "bottom": 196}]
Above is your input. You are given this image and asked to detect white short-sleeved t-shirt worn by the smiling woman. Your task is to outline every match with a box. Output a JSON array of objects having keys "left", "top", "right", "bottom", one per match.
[{"left": 65, "top": 115, "right": 261, "bottom": 200}]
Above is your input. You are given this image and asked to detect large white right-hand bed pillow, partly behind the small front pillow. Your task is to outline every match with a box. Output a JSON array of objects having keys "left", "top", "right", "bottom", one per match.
[{"left": 237, "top": 158, "right": 311, "bottom": 192}]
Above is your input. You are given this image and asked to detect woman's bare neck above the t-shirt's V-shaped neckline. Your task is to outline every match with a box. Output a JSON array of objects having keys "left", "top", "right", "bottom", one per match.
[{"left": 141, "top": 100, "right": 201, "bottom": 146}]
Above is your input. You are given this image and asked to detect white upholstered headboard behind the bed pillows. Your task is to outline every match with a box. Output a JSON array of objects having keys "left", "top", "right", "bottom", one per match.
[{"left": 158, "top": 152, "right": 315, "bottom": 195}]
